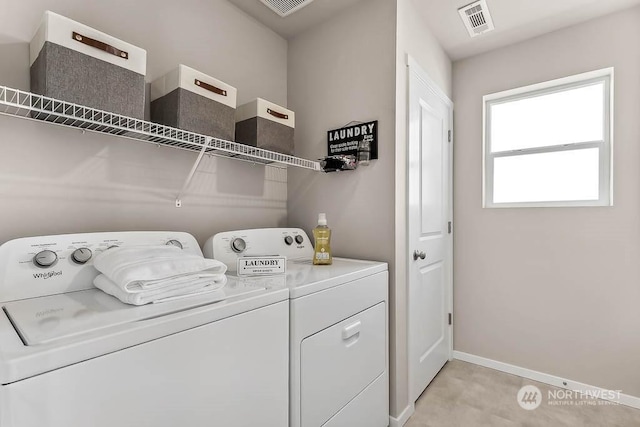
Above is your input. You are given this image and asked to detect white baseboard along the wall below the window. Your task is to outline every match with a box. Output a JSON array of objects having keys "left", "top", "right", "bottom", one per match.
[{"left": 453, "top": 351, "right": 640, "bottom": 409}]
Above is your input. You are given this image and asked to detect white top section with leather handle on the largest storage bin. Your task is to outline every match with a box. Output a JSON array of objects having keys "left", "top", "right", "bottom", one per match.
[{"left": 29, "top": 11, "right": 147, "bottom": 76}]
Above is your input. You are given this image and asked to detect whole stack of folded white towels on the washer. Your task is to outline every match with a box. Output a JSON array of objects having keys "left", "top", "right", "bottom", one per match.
[{"left": 93, "top": 246, "right": 227, "bottom": 305}]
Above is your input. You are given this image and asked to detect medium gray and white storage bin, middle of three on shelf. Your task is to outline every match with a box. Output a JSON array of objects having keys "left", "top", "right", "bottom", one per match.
[{"left": 151, "top": 65, "right": 237, "bottom": 141}]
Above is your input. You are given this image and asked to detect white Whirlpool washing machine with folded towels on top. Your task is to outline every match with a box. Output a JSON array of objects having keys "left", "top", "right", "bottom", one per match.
[{"left": 0, "top": 232, "right": 289, "bottom": 427}]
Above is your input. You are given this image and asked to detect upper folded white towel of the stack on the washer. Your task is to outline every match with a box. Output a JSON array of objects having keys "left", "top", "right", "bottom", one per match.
[{"left": 93, "top": 246, "right": 227, "bottom": 289}]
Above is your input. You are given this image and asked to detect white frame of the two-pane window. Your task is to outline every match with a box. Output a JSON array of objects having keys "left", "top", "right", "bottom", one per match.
[{"left": 482, "top": 68, "right": 613, "bottom": 208}]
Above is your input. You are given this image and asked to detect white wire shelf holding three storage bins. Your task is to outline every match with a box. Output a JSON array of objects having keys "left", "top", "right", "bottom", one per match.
[{"left": 0, "top": 86, "right": 322, "bottom": 171}]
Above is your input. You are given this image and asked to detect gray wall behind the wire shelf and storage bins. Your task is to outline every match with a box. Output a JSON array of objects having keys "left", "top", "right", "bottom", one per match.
[{"left": 0, "top": 0, "right": 287, "bottom": 243}]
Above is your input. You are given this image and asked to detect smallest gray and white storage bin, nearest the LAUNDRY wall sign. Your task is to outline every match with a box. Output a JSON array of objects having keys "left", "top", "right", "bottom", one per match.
[{"left": 236, "top": 98, "right": 295, "bottom": 155}]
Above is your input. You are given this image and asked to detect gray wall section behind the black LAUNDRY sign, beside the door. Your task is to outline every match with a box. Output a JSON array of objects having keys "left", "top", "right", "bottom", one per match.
[{"left": 288, "top": 0, "right": 395, "bottom": 262}]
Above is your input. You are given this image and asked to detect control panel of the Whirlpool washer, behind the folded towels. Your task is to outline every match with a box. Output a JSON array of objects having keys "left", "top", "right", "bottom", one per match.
[{"left": 0, "top": 231, "right": 202, "bottom": 302}]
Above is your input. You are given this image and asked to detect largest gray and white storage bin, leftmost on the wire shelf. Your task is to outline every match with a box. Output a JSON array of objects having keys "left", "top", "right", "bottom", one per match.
[{"left": 30, "top": 11, "right": 147, "bottom": 119}]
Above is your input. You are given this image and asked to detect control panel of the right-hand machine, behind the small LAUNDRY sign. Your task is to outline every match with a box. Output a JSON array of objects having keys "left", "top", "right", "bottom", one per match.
[{"left": 203, "top": 228, "right": 313, "bottom": 272}]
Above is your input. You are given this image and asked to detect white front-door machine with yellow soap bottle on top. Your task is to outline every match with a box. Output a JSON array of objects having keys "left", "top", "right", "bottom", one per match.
[{"left": 204, "top": 228, "right": 389, "bottom": 427}]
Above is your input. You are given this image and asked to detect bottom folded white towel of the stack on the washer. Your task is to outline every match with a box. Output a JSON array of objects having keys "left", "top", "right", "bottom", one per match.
[{"left": 93, "top": 274, "right": 227, "bottom": 305}]
